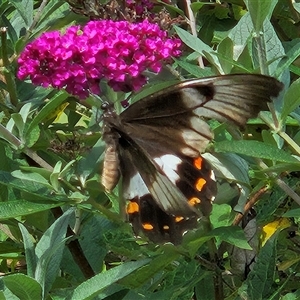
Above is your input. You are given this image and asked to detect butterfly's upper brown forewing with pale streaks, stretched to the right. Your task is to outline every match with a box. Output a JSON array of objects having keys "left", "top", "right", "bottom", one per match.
[{"left": 120, "top": 74, "right": 282, "bottom": 157}]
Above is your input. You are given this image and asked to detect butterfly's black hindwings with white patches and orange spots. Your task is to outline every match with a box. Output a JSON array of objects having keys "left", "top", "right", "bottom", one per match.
[{"left": 121, "top": 148, "right": 216, "bottom": 244}]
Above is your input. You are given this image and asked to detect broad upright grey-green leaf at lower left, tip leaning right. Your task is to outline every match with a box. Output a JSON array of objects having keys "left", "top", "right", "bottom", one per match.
[{"left": 35, "top": 209, "right": 74, "bottom": 296}]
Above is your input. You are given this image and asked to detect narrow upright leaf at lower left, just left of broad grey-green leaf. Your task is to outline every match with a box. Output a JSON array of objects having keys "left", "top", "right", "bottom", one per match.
[{"left": 18, "top": 223, "right": 37, "bottom": 278}]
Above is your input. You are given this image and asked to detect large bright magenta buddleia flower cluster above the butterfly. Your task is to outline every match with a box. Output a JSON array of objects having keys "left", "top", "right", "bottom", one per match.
[{"left": 17, "top": 20, "right": 181, "bottom": 99}]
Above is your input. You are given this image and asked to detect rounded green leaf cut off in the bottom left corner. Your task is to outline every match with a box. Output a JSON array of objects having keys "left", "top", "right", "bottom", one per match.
[{"left": 3, "top": 274, "right": 42, "bottom": 300}]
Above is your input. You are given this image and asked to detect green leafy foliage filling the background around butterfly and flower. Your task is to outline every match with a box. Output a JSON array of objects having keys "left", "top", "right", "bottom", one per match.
[{"left": 0, "top": 0, "right": 300, "bottom": 300}]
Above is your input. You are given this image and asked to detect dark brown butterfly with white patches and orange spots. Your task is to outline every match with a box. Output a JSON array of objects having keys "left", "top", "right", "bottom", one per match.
[{"left": 102, "top": 74, "right": 282, "bottom": 244}]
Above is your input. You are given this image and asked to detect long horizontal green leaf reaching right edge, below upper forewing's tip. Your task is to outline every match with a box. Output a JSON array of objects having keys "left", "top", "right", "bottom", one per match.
[{"left": 215, "top": 140, "right": 298, "bottom": 163}]
